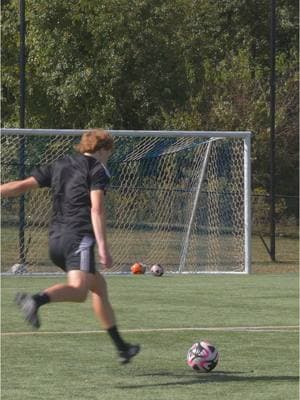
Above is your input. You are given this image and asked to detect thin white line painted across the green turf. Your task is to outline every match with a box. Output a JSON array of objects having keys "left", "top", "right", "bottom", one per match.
[{"left": 1, "top": 325, "right": 299, "bottom": 336}]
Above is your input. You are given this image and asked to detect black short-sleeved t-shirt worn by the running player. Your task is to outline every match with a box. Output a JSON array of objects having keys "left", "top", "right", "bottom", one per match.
[{"left": 31, "top": 153, "right": 110, "bottom": 235}]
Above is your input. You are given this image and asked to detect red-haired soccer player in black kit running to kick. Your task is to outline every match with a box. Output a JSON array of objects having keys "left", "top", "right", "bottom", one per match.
[{"left": 0, "top": 129, "right": 140, "bottom": 364}]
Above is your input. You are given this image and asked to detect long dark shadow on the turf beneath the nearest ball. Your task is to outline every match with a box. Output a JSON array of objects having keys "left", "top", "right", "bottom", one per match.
[{"left": 118, "top": 371, "right": 299, "bottom": 389}]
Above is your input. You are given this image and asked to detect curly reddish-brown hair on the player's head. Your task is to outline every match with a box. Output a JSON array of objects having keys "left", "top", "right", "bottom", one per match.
[{"left": 75, "top": 128, "right": 114, "bottom": 153}]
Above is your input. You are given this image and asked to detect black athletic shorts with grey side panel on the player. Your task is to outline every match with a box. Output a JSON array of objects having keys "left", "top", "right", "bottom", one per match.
[{"left": 49, "top": 232, "right": 96, "bottom": 274}]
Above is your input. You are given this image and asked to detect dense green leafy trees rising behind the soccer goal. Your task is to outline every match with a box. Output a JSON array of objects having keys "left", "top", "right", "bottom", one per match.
[{"left": 2, "top": 0, "right": 299, "bottom": 222}]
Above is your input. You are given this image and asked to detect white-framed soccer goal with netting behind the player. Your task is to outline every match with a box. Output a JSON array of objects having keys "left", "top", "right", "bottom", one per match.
[{"left": 1, "top": 129, "right": 251, "bottom": 273}]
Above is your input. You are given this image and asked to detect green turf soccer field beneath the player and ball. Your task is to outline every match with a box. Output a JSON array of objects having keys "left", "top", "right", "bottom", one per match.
[{"left": 1, "top": 274, "right": 299, "bottom": 400}]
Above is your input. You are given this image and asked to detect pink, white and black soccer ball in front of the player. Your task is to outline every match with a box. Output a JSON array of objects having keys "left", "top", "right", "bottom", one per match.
[{"left": 187, "top": 340, "right": 219, "bottom": 372}]
